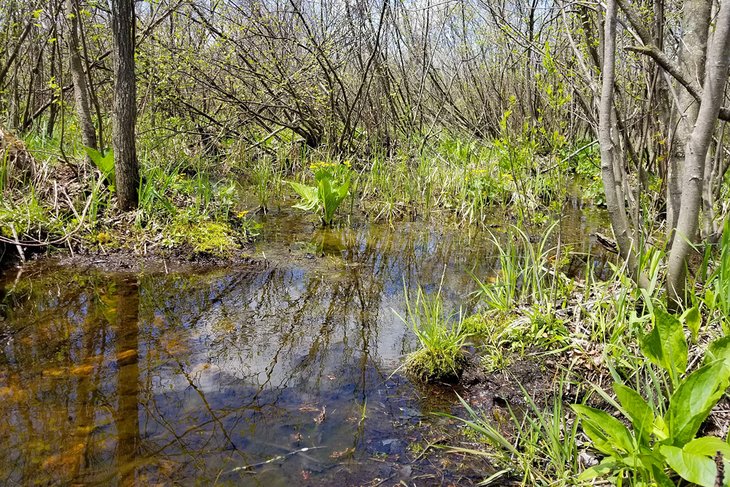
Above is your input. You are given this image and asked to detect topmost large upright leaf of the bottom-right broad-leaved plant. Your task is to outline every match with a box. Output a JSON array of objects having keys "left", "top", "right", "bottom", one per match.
[{"left": 641, "top": 308, "right": 687, "bottom": 385}]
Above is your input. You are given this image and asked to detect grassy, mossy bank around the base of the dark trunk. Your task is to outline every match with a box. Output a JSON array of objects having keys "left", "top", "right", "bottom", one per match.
[{"left": 0, "top": 121, "right": 257, "bottom": 255}]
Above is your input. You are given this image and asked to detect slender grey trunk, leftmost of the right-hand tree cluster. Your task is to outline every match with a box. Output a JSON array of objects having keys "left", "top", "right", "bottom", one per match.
[{"left": 598, "top": 0, "right": 646, "bottom": 287}]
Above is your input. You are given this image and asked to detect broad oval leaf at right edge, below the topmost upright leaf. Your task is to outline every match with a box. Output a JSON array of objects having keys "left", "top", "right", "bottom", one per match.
[{"left": 666, "top": 361, "right": 730, "bottom": 446}]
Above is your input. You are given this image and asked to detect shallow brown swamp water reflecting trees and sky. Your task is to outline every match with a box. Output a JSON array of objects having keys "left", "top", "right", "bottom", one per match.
[{"left": 0, "top": 207, "right": 604, "bottom": 487}]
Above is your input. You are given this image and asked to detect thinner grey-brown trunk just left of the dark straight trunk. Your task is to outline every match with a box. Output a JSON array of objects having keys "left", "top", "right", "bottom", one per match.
[{"left": 66, "top": 0, "right": 99, "bottom": 154}]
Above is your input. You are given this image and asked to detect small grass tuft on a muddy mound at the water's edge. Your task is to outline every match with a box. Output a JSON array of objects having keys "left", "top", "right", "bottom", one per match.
[{"left": 399, "top": 287, "right": 469, "bottom": 383}]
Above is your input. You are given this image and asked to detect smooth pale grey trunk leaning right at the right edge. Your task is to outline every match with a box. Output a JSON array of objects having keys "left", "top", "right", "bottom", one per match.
[{"left": 667, "top": 1, "right": 730, "bottom": 309}]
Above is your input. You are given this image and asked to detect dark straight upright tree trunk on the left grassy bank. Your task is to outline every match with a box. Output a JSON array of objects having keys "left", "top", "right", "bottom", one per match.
[{"left": 111, "top": 0, "right": 139, "bottom": 211}]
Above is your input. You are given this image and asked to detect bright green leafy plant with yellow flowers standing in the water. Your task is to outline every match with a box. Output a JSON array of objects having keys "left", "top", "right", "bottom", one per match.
[{"left": 288, "top": 162, "right": 352, "bottom": 226}]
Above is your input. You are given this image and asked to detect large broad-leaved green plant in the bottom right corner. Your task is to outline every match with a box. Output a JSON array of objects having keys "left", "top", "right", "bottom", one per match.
[{"left": 573, "top": 308, "right": 730, "bottom": 487}]
